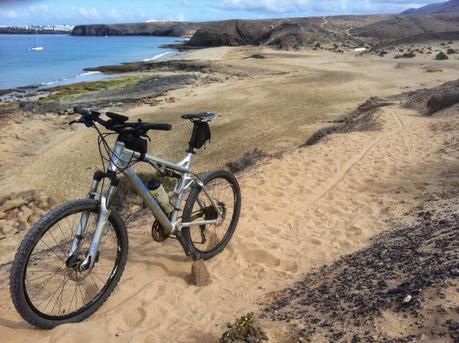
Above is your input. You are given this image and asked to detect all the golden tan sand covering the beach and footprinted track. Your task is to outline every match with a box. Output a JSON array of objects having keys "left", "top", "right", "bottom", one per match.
[{"left": 0, "top": 48, "right": 459, "bottom": 342}]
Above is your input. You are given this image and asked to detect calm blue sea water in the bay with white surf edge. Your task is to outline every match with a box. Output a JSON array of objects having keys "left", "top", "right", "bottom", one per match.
[{"left": 0, "top": 34, "right": 180, "bottom": 89}]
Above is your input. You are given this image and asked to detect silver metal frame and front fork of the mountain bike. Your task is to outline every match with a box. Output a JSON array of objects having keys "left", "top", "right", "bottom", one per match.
[{"left": 73, "top": 141, "right": 222, "bottom": 270}]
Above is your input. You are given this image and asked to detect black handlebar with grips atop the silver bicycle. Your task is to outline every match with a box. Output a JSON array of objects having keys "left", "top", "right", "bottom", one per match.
[{"left": 69, "top": 107, "right": 172, "bottom": 136}]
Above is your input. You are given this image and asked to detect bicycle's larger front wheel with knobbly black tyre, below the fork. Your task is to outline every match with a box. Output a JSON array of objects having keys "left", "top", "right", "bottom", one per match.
[{"left": 10, "top": 199, "right": 128, "bottom": 329}]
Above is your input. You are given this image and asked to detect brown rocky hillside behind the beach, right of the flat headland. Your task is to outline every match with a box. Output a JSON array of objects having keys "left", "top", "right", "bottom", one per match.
[{"left": 188, "top": 12, "right": 459, "bottom": 49}]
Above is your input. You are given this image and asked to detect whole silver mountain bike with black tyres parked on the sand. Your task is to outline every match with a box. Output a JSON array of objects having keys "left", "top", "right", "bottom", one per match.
[{"left": 10, "top": 108, "right": 241, "bottom": 329}]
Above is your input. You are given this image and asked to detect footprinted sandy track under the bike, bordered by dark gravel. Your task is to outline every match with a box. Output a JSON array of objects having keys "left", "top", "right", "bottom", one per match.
[{"left": 0, "top": 106, "right": 457, "bottom": 342}]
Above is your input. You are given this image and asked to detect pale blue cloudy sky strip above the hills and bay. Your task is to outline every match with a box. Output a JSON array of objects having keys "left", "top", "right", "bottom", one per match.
[{"left": 0, "top": 0, "right": 446, "bottom": 25}]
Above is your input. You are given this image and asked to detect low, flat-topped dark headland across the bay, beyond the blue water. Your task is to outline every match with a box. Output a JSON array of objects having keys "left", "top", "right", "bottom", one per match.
[{"left": 72, "top": 21, "right": 202, "bottom": 37}]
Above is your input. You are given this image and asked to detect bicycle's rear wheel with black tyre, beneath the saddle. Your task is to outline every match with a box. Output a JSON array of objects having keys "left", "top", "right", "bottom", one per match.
[{"left": 182, "top": 169, "right": 241, "bottom": 260}]
